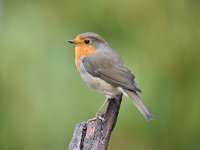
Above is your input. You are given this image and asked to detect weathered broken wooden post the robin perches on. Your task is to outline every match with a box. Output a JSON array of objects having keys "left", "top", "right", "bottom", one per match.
[{"left": 69, "top": 94, "right": 122, "bottom": 150}]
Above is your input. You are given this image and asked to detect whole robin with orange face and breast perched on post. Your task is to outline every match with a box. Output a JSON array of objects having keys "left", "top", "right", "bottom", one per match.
[{"left": 68, "top": 32, "right": 153, "bottom": 120}]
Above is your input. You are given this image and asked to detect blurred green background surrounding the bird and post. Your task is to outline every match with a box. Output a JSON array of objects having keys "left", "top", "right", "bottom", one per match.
[{"left": 0, "top": 0, "right": 200, "bottom": 150}]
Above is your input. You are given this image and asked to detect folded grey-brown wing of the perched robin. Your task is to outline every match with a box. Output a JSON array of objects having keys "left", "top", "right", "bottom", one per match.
[{"left": 82, "top": 53, "right": 141, "bottom": 92}]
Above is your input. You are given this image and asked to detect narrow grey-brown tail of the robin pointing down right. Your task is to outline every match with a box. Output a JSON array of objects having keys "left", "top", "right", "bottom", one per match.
[{"left": 124, "top": 89, "right": 153, "bottom": 120}]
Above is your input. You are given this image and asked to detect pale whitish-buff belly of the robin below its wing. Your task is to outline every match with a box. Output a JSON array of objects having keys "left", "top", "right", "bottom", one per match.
[{"left": 80, "top": 62, "right": 121, "bottom": 98}]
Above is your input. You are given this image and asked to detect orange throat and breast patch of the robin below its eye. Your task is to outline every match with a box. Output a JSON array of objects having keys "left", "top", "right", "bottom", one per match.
[{"left": 75, "top": 45, "right": 95, "bottom": 71}]
